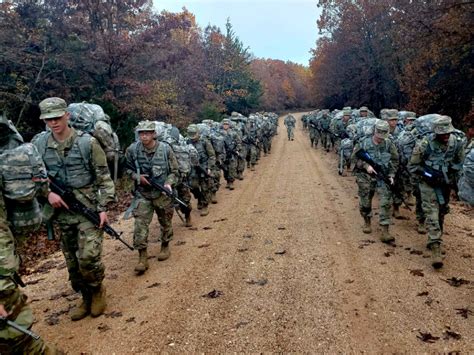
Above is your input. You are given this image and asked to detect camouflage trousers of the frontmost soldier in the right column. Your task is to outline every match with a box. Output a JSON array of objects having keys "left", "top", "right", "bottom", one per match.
[{"left": 418, "top": 181, "right": 451, "bottom": 246}]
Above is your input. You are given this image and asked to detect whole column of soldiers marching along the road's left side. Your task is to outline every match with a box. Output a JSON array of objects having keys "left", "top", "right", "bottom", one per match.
[{"left": 0, "top": 97, "right": 278, "bottom": 354}]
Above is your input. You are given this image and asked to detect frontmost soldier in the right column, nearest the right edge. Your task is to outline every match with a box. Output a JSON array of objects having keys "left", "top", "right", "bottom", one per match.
[{"left": 409, "top": 116, "right": 464, "bottom": 269}]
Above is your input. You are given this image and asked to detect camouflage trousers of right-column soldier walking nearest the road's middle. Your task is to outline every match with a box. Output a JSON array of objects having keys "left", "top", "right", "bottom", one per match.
[{"left": 355, "top": 171, "right": 392, "bottom": 226}]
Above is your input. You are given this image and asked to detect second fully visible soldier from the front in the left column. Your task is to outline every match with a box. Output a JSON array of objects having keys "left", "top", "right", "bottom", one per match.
[{"left": 125, "top": 121, "right": 178, "bottom": 275}]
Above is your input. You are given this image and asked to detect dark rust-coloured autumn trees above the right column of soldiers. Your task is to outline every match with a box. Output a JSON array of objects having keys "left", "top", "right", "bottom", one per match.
[{"left": 310, "top": 0, "right": 474, "bottom": 125}]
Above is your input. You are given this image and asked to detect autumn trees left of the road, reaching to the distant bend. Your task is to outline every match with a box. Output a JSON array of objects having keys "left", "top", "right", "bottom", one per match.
[{"left": 0, "top": 0, "right": 309, "bottom": 143}]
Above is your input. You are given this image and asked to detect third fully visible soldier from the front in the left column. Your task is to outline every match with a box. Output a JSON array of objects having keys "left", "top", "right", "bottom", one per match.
[{"left": 187, "top": 124, "right": 216, "bottom": 216}]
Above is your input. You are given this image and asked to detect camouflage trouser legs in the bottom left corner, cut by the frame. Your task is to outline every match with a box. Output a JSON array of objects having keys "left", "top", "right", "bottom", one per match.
[{"left": 0, "top": 288, "right": 47, "bottom": 355}]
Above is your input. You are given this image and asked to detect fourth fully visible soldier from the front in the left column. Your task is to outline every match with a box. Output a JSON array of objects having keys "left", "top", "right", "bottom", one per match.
[{"left": 221, "top": 119, "right": 241, "bottom": 190}]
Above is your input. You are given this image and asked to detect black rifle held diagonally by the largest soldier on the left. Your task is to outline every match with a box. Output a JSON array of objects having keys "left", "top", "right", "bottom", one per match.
[{"left": 48, "top": 176, "right": 133, "bottom": 250}]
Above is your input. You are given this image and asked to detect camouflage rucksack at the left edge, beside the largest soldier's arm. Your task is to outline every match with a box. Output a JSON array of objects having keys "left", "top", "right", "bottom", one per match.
[{"left": 0, "top": 143, "right": 47, "bottom": 232}]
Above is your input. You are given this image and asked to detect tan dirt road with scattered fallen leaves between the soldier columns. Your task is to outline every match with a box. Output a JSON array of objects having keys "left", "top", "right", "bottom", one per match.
[{"left": 26, "top": 114, "right": 474, "bottom": 354}]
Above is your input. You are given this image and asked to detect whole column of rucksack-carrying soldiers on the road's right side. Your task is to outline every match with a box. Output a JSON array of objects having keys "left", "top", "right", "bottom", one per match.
[{"left": 305, "top": 107, "right": 474, "bottom": 269}]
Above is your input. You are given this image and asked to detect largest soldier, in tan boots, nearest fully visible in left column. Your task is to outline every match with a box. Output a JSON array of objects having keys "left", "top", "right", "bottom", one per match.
[{"left": 32, "top": 97, "right": 115, "bottom": 321}]
